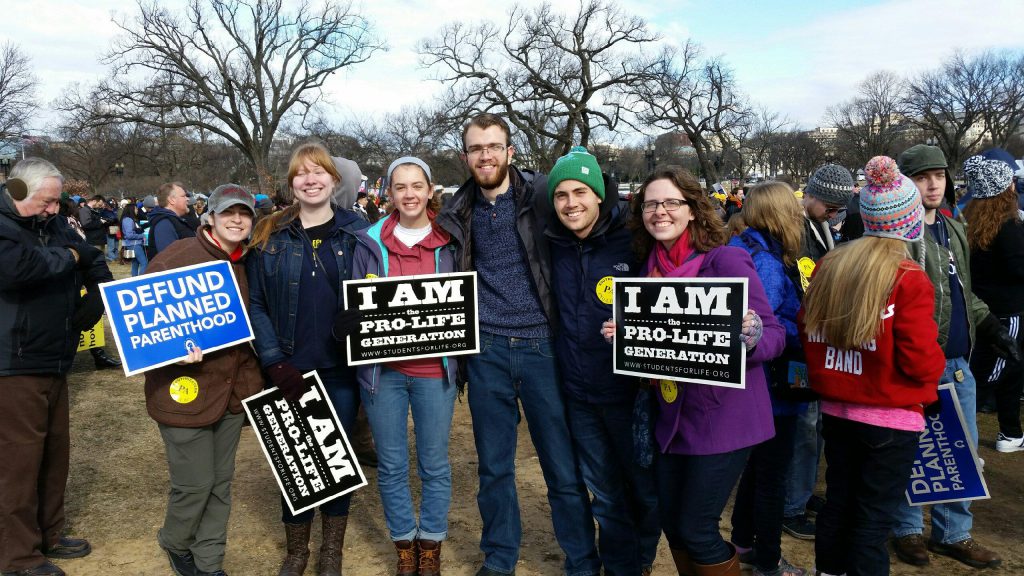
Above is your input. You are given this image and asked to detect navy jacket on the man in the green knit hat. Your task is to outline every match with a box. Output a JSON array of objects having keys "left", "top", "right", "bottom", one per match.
[{"left": 547, "top": 188, "right": 641, "bottom": 405}]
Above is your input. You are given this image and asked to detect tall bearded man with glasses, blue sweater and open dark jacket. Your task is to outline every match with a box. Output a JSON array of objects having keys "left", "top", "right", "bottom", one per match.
[{"left": 436, "top": 114, "right": 600, "bottom": 576}]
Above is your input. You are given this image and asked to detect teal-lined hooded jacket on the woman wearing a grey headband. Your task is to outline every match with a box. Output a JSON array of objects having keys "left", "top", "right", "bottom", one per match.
[{"left": 351, "top": 213, "right": 458, "bottom": 395}]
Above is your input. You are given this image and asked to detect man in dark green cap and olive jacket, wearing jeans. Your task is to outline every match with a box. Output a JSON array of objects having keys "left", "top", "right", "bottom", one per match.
[{"left": 893, "top": 145, "right": 1016, "bottom": 568}]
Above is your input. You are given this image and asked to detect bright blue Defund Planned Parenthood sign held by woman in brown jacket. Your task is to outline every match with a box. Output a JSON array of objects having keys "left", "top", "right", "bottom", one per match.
[{"left": 99, "top": 260, "right": 253, "bottom": 376}]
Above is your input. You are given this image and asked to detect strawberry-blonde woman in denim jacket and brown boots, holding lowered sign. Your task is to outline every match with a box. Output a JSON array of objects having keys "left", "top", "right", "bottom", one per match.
[{"left": 246, "top": 143, "right": 367, "bottom": 576}]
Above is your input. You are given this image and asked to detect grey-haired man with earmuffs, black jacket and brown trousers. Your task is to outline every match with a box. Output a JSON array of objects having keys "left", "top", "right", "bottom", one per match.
[{"left": 0, "top": 158, "right": 113, "bottom": 575}]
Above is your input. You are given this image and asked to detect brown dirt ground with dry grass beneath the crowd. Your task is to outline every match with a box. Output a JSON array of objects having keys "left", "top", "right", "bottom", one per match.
[{"left": 58, "top": 265, "right": 1024, "bottom": 576}]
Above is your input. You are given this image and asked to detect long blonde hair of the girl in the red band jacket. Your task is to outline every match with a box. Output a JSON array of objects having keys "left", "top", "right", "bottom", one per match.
[{"left": 804, "top": 236, "right": 920, "bottom": 349}]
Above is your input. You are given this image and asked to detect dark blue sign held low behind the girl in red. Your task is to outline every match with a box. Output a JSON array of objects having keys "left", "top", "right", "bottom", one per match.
[{"left": 906, "top": 384, "right": 989, "bottom": 506}]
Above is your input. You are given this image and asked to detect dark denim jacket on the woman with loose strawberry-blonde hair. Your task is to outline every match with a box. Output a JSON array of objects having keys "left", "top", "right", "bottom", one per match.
[{"left": 246, "top": 208, "right": 369, "bottom": 366}]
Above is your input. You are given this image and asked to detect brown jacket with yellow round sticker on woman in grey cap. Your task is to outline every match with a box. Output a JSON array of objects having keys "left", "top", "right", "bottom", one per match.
[{"left": 145, "top": 228, "right": 263, "bottom": 428}]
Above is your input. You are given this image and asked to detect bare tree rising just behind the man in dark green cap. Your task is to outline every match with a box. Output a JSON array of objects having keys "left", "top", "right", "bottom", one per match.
[{"left": 904, "top": 52, "right": 993, "bottom": 172}]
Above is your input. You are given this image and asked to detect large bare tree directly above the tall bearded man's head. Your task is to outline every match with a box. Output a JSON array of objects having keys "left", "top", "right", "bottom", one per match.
[{"left": 419, "top": 0, "right": 657, "bottom": 169}]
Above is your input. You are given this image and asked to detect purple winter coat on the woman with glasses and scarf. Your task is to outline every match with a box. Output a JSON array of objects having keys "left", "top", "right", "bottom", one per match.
[{"left": 644, "top": 241, "right": 785, "bottom": 455}]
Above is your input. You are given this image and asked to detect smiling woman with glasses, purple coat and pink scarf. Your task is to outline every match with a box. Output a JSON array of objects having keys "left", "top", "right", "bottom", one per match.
[{"left": 604, "top": 166, "right": 785, "bottom": 576}]
